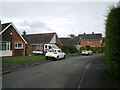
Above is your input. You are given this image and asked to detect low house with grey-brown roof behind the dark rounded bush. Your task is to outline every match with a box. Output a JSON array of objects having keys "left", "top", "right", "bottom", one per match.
[{"left": 60, "top": 34, "right": 80, "bottom": 50}]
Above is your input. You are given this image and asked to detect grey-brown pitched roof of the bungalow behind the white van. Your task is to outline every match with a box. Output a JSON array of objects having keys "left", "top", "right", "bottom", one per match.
[{"left": 22, "top": 33, "right": 56, "bottom": 44}]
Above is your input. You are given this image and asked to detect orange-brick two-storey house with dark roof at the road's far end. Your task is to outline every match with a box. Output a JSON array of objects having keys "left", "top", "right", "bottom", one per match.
[{"left": 78, "top": 32, "right": 103, "bottom": 47}]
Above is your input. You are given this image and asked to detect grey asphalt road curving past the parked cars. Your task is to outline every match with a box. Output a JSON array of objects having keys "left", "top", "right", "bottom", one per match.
[{"left": 2, "top": 54, "right": 108, "bottom": 88}]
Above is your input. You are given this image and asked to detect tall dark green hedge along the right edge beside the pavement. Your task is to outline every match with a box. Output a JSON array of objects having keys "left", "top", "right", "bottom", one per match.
[{"left": 105, "top": 7, "right": 120, "bottom": 80}]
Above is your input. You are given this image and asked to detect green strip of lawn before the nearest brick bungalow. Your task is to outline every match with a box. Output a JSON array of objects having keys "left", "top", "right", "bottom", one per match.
[{"left": 2, "top": 56, "right": 45, "bottom": 63}]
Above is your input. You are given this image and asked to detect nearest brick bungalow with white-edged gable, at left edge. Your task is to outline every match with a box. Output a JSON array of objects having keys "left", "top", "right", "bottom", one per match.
[{"left": 0, "top": 22, "right": 27, "bottom": 57}]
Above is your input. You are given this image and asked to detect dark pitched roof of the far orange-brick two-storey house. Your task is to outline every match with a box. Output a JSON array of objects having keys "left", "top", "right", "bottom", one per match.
[{"left": 78, "top": 34, "right": 102, "bottom": 40}]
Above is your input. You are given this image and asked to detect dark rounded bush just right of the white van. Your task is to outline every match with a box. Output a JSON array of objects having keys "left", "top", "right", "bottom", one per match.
[{"left": 62, "top": 45, "right": 78, "bottom": 53}]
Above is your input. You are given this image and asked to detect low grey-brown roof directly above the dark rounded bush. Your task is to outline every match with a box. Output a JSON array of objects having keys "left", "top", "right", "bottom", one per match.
[{"left": 60, "top": 37, "right": 79, "bottom": 45}]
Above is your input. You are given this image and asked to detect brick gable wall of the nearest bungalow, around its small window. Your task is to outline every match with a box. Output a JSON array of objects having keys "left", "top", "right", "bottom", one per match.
[{"left": 2, "top": 26, "right": 25, "bottom": 56}]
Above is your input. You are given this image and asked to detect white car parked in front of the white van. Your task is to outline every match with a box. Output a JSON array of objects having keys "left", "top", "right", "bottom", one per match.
[{"left": 45, "top": 49, "right": 65, "bottom": 60}]
